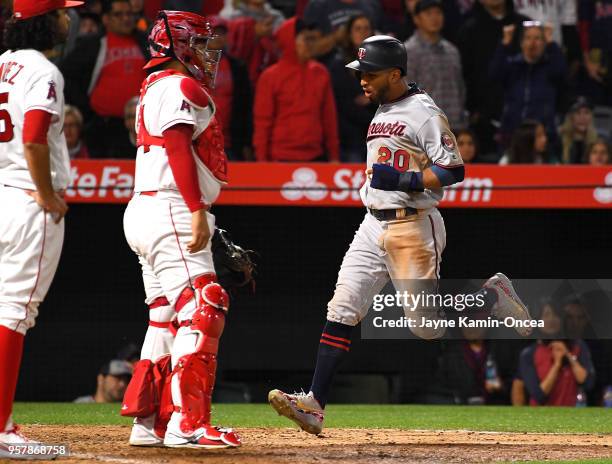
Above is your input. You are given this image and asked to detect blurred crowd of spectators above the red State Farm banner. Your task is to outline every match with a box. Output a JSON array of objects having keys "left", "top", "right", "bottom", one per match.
[{"left": 3, "top": 0, "right": 612, "bottom": 165}]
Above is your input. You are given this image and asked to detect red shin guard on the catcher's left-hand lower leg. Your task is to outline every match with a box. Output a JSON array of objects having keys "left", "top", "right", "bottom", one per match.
[{"left": 121, "top": 355, "right": 172, "bottom": 417}]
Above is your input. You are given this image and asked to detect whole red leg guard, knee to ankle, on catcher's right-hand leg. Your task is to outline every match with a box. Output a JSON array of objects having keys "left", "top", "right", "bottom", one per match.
[{"left": 171, "top": 274, "right": 229, "bottom": 435}]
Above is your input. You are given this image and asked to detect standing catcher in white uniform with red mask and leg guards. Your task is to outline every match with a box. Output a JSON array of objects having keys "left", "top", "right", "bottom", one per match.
[{"left": 122, "top": 11, "right": 240, "bottom": 448}]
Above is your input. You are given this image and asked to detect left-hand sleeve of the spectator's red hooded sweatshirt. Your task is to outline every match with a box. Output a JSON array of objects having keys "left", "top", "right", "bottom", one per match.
[{"left": 253, "top": 73, "right": 274, "bottom": 161}]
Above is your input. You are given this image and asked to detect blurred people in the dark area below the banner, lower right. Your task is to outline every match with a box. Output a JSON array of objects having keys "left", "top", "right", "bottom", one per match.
[{"left": 420, "top": 292, "right": 612, "bottom": 407}]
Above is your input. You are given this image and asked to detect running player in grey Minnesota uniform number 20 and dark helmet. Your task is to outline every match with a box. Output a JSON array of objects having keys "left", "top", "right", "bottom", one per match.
[{"left": 268, "top": 35, "right": 530, "bottom": 434}]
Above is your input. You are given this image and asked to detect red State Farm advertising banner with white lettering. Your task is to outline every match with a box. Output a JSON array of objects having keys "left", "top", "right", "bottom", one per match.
[{"left": 67, "top": 160, "right": 612, "bottom": 208}]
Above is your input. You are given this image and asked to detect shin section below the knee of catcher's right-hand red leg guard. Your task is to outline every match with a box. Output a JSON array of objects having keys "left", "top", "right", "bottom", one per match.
[{"left": 172, "top": 353, "right": 217, "bottom": 434}]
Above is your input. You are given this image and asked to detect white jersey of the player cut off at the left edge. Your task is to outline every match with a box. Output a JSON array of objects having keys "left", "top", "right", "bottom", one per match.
[{"left": 0, "top": 49, "right": 70, "bottom": 190}]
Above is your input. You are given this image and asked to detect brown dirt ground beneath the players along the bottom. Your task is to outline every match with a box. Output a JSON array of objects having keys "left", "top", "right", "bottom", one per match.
[{"left": 13, "top": 425, "right": 612, "bottom": 464}]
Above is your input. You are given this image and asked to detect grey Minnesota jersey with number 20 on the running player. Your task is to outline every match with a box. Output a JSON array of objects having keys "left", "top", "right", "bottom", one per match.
[{"left": 360, "top": 90, "right": 463, "bottom": 209}]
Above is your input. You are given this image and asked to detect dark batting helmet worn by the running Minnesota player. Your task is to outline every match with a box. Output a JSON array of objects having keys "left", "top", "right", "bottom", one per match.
[{"left": 346, "top": 35, "right": 408, "bottom": 76}]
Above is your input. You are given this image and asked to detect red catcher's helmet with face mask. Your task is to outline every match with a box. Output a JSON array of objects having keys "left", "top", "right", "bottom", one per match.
[{"left": 144, "top": 10, "right": 221, "bottom": 87}]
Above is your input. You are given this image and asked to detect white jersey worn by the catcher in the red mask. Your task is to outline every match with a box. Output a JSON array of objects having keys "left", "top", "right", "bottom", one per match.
[{"left": 134, "top": 71, "right": 222, "bottom": 204}]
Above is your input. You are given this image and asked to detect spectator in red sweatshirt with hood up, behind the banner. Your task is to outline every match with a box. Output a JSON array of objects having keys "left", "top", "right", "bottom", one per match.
[{"left": 253, "top": 18, "right": 340, "bottom": 161}]
